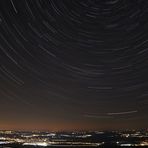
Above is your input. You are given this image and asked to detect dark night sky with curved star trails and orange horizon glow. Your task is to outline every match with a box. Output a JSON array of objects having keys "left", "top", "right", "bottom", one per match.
[{"left": 0, "top": 0, "right": 148, "bottom": 130}]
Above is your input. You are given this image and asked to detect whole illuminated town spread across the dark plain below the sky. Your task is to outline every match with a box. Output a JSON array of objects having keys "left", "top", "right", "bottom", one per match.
[{"left": 0, "top": 130, "right": 148, "bottom": 148}]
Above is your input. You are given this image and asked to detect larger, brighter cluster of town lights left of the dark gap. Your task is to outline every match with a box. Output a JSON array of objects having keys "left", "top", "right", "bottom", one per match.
[{"left": 0, "top": 131, "right": 104, "bottom": 147}]
